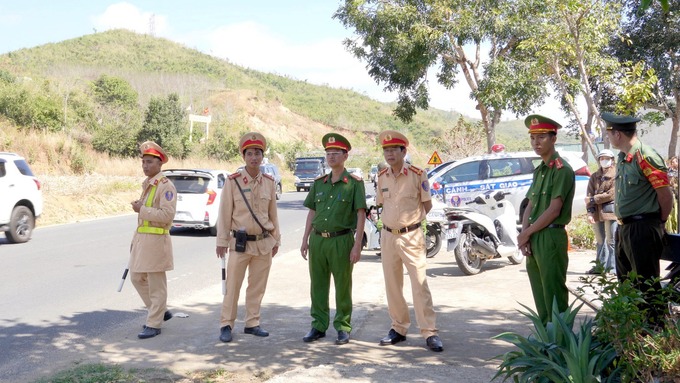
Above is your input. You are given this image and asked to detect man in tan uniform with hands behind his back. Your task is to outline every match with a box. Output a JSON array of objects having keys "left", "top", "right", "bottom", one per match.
[{"left": 376, "top": 130, "right": 444, "bottom": 352}]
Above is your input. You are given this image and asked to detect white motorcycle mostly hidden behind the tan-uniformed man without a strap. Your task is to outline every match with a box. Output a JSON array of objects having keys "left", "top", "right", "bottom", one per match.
[{"left": 362, "top": 195, "right": 446, "bottom": 258}]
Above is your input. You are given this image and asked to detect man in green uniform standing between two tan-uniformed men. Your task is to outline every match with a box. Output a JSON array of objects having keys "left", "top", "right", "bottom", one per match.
[{"left": 300, "top": 133, "right": 366, "bottom": 344}]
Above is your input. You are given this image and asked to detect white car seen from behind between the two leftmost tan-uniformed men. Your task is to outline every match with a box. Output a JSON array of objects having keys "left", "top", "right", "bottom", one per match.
[{"left": 163, "top": 169, "right": 230, "bottom": 236}]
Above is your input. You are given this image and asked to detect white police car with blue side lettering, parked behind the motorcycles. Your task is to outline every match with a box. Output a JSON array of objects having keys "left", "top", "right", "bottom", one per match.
[{"left": 428, "top": 148, "right": 590, "bottom": 217}]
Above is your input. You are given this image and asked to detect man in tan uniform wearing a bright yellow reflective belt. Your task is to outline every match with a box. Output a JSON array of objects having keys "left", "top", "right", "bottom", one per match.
[{"left": 129, "top": 141, "right": 177, "bottom": 339}]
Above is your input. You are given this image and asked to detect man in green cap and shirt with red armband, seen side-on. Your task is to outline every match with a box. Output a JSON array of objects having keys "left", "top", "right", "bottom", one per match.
[{"left": 602, "top": 113, "right": 673, "bottom": 318}]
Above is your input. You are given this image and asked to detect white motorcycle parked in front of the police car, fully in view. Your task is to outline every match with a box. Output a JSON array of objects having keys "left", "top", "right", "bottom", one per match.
[{"left": 444, "top": 190, "right": 524, "bottom": 275}]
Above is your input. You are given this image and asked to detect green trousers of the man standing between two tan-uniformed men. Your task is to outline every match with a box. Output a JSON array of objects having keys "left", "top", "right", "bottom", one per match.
[{"left": 309, "top": 232, "right": 354, "bottom": 332}]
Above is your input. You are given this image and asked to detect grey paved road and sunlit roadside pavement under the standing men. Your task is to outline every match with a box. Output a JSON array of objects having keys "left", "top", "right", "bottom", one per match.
[{"left": 0, "top": 193, "right": 593, "bottom": 382}]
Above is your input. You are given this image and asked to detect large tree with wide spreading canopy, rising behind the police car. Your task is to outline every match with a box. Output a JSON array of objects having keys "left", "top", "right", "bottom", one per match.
[{"left": 334, "top": 0, "right": 545, "bottom": 150}]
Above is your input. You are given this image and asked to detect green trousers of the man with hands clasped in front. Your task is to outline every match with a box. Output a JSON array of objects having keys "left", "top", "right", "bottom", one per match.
[{"left": 527, "top": 228, "right": 569, "bottom": 323}]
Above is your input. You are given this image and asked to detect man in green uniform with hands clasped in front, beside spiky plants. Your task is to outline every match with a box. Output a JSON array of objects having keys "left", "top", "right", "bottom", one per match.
[{"left": 517, "top": 114, "right": 576, "bottom": 323}]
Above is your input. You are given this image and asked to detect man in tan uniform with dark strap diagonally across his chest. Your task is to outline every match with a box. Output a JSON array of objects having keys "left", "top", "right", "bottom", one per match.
[{"left": 215, "top": 132, "right": 281, "bottom": 342}]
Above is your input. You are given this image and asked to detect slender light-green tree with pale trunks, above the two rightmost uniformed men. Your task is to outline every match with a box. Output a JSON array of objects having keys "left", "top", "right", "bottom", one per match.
[{"left": 519, "top": 0, "right": 621, "bottom": 160}]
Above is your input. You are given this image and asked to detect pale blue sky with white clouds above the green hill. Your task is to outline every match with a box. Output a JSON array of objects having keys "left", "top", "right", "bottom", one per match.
[{"left": 0, "top": 0, "right": 561, "bottom": 121}]
